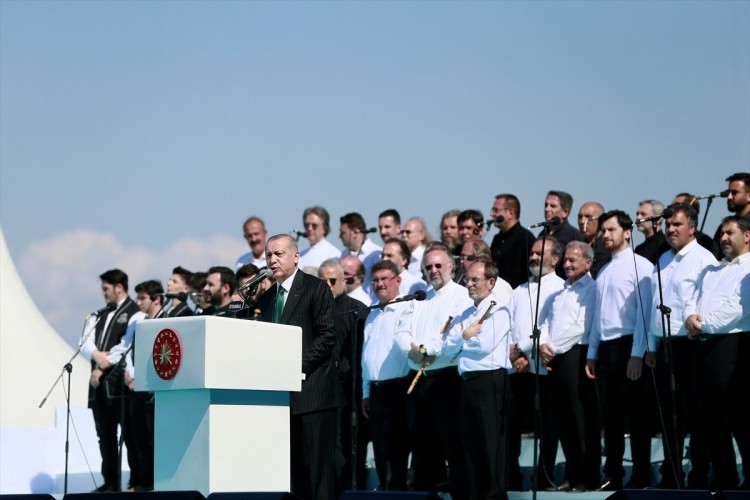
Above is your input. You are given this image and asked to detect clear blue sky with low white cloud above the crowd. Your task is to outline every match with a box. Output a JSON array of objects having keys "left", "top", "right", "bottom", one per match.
[{"left": 0, "top": 0, "right": 750, "bottom": 350}]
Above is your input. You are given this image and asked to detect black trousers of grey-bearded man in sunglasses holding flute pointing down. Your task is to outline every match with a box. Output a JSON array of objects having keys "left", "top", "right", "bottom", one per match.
[{"left": 409, "top": 367, "right": 469, "bottom": 500}]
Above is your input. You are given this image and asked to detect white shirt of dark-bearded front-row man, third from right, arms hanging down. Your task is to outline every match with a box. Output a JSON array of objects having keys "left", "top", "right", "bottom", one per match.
[{"left": 586, "top": 247, "right": 654, "bottom": 359}]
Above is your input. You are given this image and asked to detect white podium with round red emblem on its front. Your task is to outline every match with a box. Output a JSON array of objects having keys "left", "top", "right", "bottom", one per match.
[{"left": 134, "top": 316, "right": 303, "bottom": 496}]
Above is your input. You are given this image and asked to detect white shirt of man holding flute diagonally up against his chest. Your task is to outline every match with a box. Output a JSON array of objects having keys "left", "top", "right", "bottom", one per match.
[{"left": 443, "top": 294, "right": 511, "bottom": 374}]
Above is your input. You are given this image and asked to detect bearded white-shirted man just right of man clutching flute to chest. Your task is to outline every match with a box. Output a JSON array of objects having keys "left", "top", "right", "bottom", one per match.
[{"left": 508, "top": 236, "right": 563, "bottom": 491}]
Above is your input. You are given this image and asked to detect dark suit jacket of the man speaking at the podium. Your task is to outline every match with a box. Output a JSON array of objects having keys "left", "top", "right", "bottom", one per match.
[{"left": 260, "top": 270, "right": 343, "bottom": 415}]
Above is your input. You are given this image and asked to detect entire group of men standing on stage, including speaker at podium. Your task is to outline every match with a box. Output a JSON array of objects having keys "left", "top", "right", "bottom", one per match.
[{"left": 82, "top": 173, "right": 750, "bottom": 499}]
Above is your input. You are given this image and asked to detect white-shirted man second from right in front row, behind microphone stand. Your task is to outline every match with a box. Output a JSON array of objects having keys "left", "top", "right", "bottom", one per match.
[{"left": 646, "top": 204, "right": 718, "bottom": 489}]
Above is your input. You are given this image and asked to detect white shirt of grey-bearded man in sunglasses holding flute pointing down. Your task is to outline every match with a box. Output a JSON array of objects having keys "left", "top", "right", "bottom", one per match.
[{"left": 395, "top": 281, "right": 474, "bottom": 370}]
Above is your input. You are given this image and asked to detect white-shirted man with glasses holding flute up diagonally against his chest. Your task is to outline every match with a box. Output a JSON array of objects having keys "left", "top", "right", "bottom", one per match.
[{"left": 444, "top": 261, "right": 511, "bottom": 499}]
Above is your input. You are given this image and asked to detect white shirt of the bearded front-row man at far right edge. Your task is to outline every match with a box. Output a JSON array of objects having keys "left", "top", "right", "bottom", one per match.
[{"left": 690, "top": 253, "right": 750, "bottom": 334}]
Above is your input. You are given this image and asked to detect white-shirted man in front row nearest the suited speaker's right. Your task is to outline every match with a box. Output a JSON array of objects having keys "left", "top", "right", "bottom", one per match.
[{"left": 362, "top": 260, "right": 411, "bottom": 491}]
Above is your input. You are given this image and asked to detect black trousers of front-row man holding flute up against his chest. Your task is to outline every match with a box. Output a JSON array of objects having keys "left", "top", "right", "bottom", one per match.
[{"left": 461, "top": 369, "right": 510, "bottom": 499}]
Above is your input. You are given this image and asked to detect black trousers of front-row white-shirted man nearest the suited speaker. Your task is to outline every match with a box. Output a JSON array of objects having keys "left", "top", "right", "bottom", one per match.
[{"left": 370, "top": 377, "right": 410, "bottom": 491}]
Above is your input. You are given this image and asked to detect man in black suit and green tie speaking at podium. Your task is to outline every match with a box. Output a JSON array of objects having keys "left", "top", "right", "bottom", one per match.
[{"left": 261, "top": 234, "right": 343, "bottom": 500}]
